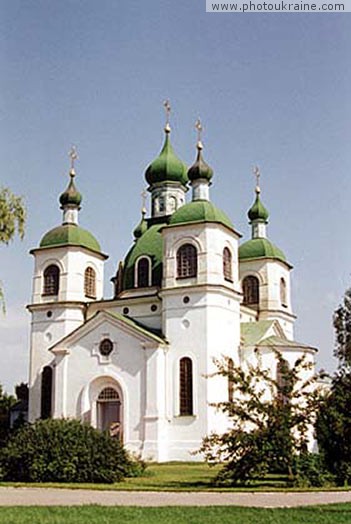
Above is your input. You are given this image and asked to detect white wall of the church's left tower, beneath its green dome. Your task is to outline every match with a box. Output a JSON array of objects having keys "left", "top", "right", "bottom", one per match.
[{"left": 28, "top": 246, "right": 104, "bottom": 421}]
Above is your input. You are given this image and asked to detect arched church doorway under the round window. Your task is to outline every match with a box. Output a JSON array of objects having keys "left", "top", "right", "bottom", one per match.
[{"left": 96, "top": 386, "right": 122, "bottom": 440}]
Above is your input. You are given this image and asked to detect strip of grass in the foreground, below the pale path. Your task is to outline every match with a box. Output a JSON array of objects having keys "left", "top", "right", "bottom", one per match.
[{"left": 0, "top": 504, "right": 351, "bottom": 524}]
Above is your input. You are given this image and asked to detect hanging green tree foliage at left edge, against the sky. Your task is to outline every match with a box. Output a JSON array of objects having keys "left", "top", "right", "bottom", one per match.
[{"left": 0, "top": 188, "right": 26, "bottom": 311}]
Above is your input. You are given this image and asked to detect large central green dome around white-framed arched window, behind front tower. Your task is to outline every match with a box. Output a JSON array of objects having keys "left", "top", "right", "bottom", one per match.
[{"left": 123, "top": 223, "right": 166, "bottom": 289}]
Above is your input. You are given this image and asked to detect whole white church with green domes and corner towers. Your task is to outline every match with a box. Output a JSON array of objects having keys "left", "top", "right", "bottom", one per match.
[{"left": 28, "top": 116, "right": 316, "bottom": 462}]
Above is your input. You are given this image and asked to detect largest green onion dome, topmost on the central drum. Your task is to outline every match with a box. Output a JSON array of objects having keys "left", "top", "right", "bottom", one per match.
[{"left": 145, "top": 127, "right": 188, "bottom": 186}]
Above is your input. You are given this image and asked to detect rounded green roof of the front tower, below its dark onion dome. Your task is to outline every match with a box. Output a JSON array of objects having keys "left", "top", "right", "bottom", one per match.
[{"left": 170, "top": 200, "right": 234, "bottom": 229}]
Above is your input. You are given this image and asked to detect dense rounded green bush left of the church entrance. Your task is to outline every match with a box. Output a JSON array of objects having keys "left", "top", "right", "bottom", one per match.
[{"left": 0, "top": 419, "right": 143, "bottom": 483}]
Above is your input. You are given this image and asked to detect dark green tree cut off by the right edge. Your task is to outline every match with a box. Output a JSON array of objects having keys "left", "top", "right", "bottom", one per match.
[{"left": 317, "top": 288, "right": 351, "bottom": 485}]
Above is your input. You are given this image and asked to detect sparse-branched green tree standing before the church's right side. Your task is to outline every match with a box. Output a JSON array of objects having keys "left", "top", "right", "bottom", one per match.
[{"left": 199, "top": 352, "right": 326, "bottom": 484}]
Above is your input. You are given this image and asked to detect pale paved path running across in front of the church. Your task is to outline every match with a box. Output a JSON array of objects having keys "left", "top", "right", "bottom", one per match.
[{"left": 0, "top": 488, "right": 351, "bottom": 508}]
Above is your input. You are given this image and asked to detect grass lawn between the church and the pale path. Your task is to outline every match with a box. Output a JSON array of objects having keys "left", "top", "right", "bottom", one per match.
[{"left": 0, "top": 462, "right": 351, "bottom": 492}]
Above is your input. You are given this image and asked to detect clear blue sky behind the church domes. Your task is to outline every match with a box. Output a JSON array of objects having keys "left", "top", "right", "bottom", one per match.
[{"left": 0, "top": 0, "right": 351, "bottom": 391}]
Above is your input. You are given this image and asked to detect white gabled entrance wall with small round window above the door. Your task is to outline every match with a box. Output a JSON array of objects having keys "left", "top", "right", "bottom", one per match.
[{"left": 53, "top": 321, "right": 167, "bottom": 461}]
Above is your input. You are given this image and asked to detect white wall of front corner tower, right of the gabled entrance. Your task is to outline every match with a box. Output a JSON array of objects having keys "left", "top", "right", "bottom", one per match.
[{"left": 161, "top": 223, "right": 240, "bottom": 460}]
